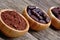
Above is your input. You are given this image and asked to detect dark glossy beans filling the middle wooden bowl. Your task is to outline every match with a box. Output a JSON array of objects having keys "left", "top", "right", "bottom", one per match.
[{"left": 27, "top": 5, "right": 50, "bottom": 23}]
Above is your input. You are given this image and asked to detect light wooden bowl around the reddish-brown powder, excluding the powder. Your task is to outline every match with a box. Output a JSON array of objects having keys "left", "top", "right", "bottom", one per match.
[{"left": 0, "top": 9, "right": 29, "bottom": 37}]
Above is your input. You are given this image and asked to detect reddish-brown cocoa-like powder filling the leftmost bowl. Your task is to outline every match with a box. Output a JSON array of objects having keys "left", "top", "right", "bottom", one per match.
[{"left": 1, "top": 11, "right": 26, "bottom": 30}]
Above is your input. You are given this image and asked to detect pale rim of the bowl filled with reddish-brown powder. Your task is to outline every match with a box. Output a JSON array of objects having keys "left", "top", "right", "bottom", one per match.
[{"left": 0, "top": 9, "right": 29, "bottom": 32}]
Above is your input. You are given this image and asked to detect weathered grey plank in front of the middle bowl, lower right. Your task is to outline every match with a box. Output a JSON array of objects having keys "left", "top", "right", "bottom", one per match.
[{"left": 30, "top": 28, "right": 60, "bottom": 40}]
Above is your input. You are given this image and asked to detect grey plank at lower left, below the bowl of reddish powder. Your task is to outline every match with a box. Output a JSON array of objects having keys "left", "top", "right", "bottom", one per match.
[{"left": 0, "top": 31, "right": 38, "bottom": 40}]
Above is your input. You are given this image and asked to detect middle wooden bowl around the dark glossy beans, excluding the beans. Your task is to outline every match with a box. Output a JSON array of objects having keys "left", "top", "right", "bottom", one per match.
[{"left": 23, "top": 7, "right": 51, "bottom": 31}]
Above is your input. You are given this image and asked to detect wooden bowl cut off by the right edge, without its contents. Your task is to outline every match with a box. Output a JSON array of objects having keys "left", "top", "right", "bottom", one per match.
[{"left": 48, "top": 6, "right": 60, "bottom": 29}]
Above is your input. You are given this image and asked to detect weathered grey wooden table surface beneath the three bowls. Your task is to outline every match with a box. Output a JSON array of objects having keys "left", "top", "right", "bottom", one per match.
[{"left": 0, "top": 0, "right": 60, "bottom": 40}]
